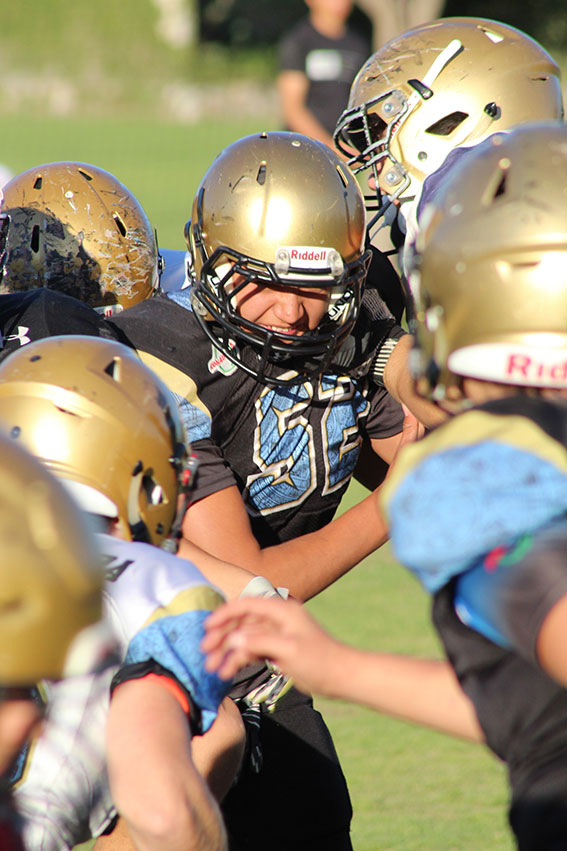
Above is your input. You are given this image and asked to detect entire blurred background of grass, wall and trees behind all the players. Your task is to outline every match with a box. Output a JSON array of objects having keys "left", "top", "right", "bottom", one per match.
[{"left": 0, "top": 0, "right": 567, "bottom": 851}]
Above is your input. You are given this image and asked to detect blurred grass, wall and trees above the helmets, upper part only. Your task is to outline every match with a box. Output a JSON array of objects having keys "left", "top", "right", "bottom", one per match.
[{"left": 0, "top": 0, "right": 567, "bottom": 248}]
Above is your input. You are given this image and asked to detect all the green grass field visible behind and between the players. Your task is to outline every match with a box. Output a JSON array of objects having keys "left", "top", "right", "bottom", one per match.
[{"left": 0, "top": 115, "right": 513, "bottom": 851}]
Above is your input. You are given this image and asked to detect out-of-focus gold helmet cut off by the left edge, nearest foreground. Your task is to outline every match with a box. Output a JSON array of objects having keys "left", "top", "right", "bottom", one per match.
[{"left": 0, "top": 435, "right": 103, "bottom": 684}]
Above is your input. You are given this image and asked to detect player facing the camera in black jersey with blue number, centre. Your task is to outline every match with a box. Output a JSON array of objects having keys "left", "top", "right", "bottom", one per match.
[{"left": 109, "top": 132, "right": 403, "bottom": 851}]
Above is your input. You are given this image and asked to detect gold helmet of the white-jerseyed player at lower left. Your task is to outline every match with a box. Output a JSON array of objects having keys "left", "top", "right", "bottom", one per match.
[{"left": 0, "top": 335, "right": 197, "bottom": 548}]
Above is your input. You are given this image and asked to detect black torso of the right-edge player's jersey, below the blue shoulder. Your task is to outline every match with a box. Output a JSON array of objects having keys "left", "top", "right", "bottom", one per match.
[{"left": 433, "top": 568, "right": 567, "bottom": 851}]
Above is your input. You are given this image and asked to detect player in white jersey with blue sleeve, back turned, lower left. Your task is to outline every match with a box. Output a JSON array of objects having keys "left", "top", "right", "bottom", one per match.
[{"left": 0, "top": 335, "right": 242, "bottom": 851}]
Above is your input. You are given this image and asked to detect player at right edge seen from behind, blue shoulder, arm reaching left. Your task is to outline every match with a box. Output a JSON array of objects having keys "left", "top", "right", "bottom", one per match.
[{"left": 204, "top": 124, "right": 567, "bottom": 851}]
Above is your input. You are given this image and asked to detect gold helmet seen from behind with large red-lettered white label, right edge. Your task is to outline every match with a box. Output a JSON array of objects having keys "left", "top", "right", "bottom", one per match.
[{"left": 410, "top": 123, "right": 567, "bottom": 398}]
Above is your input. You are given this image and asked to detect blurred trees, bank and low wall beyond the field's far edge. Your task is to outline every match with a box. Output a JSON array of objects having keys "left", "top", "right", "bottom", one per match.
[{"left": 0, "top": 0, "right": 567, "bottom": 123}]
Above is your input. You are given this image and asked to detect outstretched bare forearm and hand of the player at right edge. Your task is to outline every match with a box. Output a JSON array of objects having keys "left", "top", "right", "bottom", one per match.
[{"left": 202, "top": 599, "right": 482, "bottom": 742}]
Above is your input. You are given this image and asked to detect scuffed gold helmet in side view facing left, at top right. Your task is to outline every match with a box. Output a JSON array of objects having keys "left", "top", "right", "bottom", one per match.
[{"left": 335, "top": 18, "right": 563, "bottom": 218}]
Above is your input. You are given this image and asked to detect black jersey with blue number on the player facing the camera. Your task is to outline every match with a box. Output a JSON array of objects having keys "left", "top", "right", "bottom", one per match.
[{"left": 110, "top": 291, "right": 403, "bottom": 546}]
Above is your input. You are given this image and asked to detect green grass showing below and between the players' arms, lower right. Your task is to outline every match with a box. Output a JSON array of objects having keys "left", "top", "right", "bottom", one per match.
[{"left": 309, "top": 482, "right": 514, "bottom": 851}]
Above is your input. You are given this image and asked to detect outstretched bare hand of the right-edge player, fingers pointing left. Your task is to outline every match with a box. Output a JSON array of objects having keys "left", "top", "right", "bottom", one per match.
[{"left": 201, "top": 598, "right": 343, "bottom": 694}]
